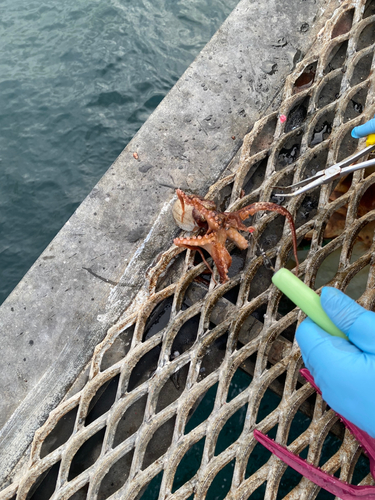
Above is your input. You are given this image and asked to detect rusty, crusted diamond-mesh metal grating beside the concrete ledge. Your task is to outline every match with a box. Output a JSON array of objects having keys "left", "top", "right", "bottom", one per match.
[{"left": 0, "top": 0, "right": 375, "bottom": 500}]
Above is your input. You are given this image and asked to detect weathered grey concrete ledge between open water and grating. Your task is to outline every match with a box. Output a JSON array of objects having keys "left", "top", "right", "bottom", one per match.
[{"left": 0, "top": 0, "right": 332, "bottom": 483}]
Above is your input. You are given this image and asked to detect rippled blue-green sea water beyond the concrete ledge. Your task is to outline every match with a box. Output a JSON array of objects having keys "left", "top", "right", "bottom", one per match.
[{"left": 0, "top": 0, "right": 238, "bottom": 304}]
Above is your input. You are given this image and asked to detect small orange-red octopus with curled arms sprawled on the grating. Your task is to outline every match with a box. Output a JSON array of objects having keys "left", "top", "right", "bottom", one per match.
[{"left": 173, "top": 189, "right": 298, "bottom": 283}]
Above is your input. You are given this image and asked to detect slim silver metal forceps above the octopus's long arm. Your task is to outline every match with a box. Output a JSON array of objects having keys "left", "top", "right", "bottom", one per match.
[{"left": 275, "top": 144, "right": 375, "bottom": 196}]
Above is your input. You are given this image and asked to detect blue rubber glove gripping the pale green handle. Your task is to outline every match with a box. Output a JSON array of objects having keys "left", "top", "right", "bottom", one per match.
[{"left": 296, "top": 287, "right": 375, "bottom": 438}]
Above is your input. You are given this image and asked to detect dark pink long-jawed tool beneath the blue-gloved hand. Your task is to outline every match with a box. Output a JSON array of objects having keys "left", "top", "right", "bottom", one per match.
[{"left": 254, "top": 368, "right": 375, "bottom": 500}]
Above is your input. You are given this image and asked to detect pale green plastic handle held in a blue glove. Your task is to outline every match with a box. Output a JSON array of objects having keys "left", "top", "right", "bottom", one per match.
[{"left": 272, "top": 268, "right": 348, "bottom": 340}]
